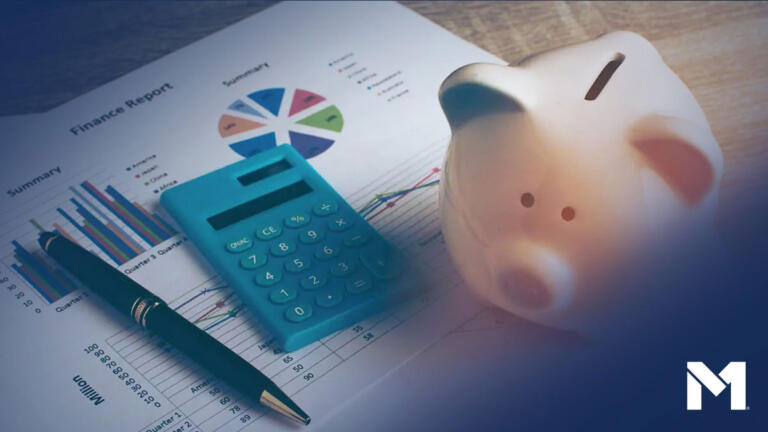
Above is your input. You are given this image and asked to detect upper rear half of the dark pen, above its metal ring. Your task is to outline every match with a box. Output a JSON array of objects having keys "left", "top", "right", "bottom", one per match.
[{"left": 43, "top": 235, "right": 162, "bottom": 318}]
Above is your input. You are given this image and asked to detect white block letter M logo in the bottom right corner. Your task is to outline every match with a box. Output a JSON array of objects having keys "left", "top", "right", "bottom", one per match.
[{"left": 687, "top": 362, "right": 747, "bottom": 411}]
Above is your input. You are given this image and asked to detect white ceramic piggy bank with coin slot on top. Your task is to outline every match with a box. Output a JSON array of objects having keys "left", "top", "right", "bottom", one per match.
[{"left": 440, "top": 32, "right": 723, "bottom": 330}]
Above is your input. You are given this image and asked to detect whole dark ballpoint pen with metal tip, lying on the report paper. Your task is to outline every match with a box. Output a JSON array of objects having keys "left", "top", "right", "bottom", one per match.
[{"left": 38, "top": 232, "right": 310, "bottom": 425}]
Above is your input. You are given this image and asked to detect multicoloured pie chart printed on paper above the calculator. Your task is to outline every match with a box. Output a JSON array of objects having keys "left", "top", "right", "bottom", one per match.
[{"left": 219, "top": 87, "right": 344, "bottom": 159}]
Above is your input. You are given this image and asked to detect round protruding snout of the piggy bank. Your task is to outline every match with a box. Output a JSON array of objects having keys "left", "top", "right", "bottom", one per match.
[{"left": 497, "top": 244, "right": 573, "bottom": 311}]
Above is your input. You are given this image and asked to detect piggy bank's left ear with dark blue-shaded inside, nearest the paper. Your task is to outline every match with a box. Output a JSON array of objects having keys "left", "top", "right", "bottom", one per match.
[{"left": 440, "top": 63, "right": 525, "bottom": 130}]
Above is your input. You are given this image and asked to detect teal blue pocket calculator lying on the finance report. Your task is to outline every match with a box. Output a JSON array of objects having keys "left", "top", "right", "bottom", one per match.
[{"left": 160, "top": 144, "right": 410, "bottom": 351}]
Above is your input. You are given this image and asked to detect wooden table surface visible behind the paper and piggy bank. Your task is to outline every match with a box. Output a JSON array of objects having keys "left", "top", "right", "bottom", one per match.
[{"left": 0, "top": 1, "right": 768, "bottom": 250}]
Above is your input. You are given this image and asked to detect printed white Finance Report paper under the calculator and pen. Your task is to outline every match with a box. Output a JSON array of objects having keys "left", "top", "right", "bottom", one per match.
[{"left": 0, "top": 2, "right": 502, "bottom": 432}]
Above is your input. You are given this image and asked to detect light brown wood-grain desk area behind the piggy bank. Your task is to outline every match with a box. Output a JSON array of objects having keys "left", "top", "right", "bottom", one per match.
[{"left": 404, "top": 1, "right": 768, "bottom": 253}]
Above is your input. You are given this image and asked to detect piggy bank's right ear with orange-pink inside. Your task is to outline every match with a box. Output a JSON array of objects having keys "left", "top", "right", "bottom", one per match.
[{"left": 629, "top": 116, "right": 722, "bottom": 206}]
